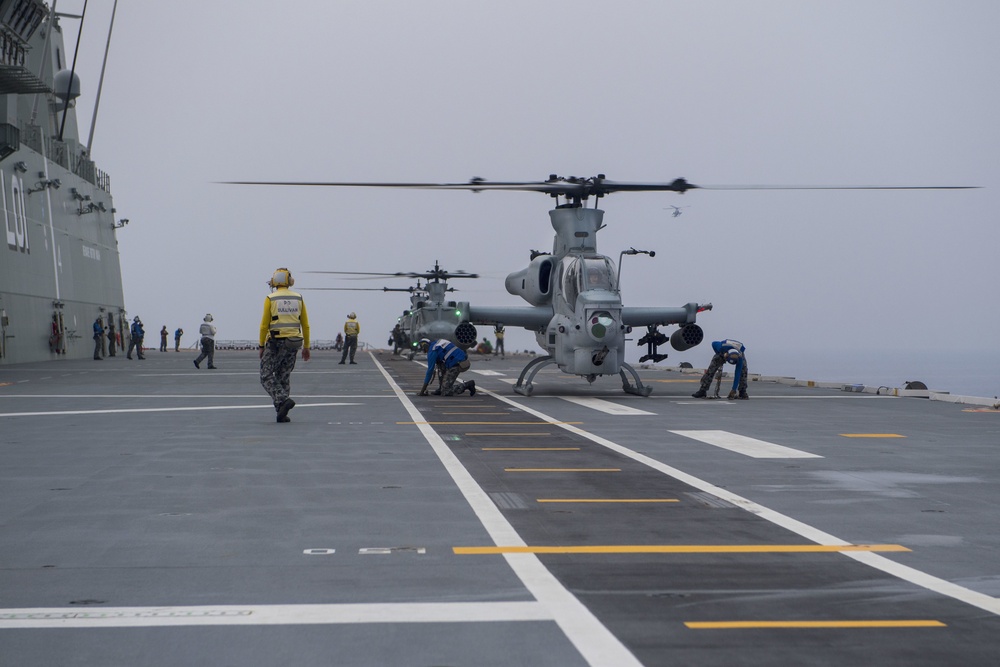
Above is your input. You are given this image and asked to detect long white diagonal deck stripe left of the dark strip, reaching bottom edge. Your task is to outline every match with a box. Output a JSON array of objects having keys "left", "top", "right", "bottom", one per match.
[{"left": 372, "top": 355, "right": 641, "bottom": 667}]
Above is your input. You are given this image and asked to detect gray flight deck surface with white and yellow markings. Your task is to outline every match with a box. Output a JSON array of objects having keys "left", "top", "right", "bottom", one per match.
[{"left": 0, "top": 350, "right": 1000, "bottom": 667}]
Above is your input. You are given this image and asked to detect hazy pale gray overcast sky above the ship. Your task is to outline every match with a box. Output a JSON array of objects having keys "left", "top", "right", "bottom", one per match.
[{"left": 59, "top": 0, "right": 1000, "bottom": 384}]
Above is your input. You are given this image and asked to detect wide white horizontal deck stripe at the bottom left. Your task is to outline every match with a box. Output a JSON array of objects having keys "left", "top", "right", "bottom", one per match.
[{"left": 0, "top": 602, "right": 553, "bottom": 630}]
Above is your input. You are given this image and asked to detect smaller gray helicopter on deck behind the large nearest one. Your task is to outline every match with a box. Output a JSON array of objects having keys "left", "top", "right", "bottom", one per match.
[{"left": 303, "top": 260, "right": 479, "bottom": 359}]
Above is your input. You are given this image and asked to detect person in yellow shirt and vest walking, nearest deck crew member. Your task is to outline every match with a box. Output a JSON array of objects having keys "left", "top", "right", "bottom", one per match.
[{"left": 259, "top": 268, "right": 309, "bottom": 423}]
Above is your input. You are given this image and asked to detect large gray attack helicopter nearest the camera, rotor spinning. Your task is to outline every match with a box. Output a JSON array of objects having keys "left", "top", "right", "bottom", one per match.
[{"left": 223, "top": 174, "right": 968, "bottom": 396}]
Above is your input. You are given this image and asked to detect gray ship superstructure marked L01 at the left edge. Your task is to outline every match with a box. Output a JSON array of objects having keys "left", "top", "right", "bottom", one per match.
[{"left": 0, "top": 0, "right": 128, "bottom": 364}]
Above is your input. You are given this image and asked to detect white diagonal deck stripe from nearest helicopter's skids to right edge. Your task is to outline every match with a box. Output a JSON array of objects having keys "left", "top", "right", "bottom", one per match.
[{"left": 484, "top": 390, "right": 1000, "bottom": 616}]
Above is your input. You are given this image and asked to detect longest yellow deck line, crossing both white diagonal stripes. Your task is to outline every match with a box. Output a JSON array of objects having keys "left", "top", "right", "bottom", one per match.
[{"left": 452, "top": 544, "right": 909, "bottom": 556}]
